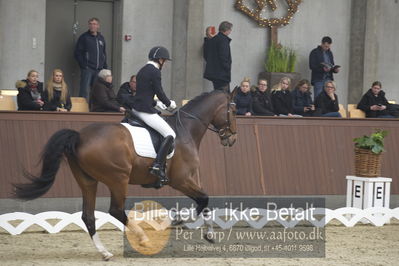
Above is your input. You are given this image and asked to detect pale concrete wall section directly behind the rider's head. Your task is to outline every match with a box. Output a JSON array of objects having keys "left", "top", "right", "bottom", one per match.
[{"left": 122, "top": 0, "right": 173, "bottom": 95}]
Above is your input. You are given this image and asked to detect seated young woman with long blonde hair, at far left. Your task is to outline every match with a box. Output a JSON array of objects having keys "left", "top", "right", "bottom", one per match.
[{"left": 43, "top": 69, "right": 72, "bottom": 112}]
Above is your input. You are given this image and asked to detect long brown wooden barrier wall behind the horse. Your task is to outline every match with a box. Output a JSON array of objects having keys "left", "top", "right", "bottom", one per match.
[{"left": 0, "top": 111, "right": 399, "bottom": 198}]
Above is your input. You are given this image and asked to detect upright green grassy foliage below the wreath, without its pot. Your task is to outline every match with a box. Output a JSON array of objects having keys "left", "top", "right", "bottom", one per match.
[{"left": 265, "top": 44, "right": 297, "bottom": 73}]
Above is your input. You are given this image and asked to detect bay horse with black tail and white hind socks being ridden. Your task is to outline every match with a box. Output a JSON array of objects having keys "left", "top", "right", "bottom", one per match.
[{"left": 14, "top": 91, "right": 236, "bottom": 260}]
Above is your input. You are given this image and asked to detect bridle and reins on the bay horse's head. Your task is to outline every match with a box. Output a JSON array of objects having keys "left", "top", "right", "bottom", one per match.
[{"left": 177, "top": 102, "right": 237, "bottom": 140}]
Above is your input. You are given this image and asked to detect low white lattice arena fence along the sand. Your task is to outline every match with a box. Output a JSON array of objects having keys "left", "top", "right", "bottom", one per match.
[{"left": 0, "top": 207, "right": 399, "bottom": 235}]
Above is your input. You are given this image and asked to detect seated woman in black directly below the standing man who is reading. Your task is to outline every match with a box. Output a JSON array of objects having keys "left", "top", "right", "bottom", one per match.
[{"left": 314, "top": 80, "right": 341, "bottom": 117}]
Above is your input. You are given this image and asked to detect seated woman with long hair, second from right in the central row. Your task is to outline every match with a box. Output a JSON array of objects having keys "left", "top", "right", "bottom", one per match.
[{"left": 291, "top": 79, "right": 316, "bottom": 116}]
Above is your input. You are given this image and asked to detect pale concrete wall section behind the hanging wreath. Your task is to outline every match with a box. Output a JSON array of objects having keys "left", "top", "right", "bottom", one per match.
[{"left": 204, "top": 0, "right": 351, "bottom": 104}]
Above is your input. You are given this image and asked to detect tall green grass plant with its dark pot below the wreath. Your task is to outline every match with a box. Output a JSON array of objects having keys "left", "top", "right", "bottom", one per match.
[{"left": 258, "top": 44, "right": 301, "bottom": 89}]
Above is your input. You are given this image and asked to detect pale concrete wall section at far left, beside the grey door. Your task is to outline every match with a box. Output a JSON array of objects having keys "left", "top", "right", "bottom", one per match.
[{"left": 0, "top": 0, "right": 46, "bottom": 89}]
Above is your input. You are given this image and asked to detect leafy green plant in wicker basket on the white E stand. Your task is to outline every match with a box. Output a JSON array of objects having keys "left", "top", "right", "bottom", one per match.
[{"left": 353, "top": 129, "right": 388, "bottom": 177}]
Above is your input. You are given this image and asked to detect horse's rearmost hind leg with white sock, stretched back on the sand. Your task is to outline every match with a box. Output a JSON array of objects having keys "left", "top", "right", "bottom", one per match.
[{"left": 69, "top": 160, "right": 113, "bottom": 260}]
